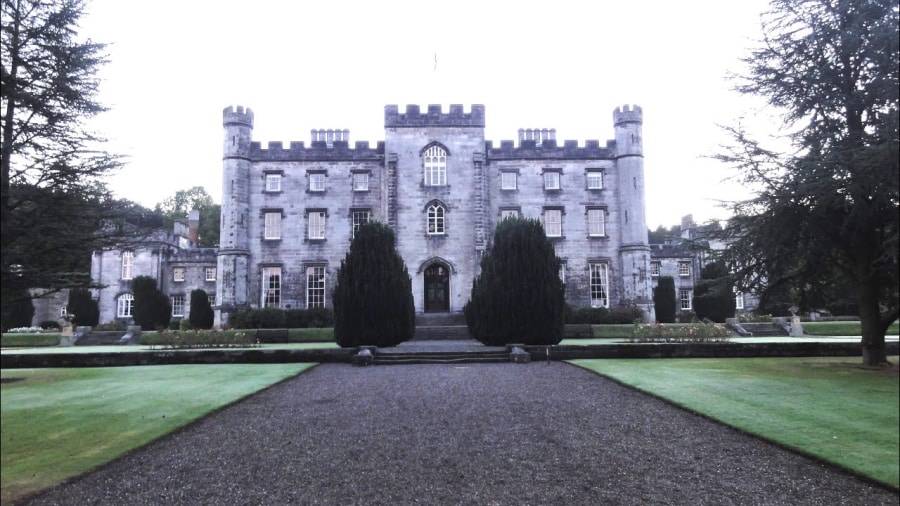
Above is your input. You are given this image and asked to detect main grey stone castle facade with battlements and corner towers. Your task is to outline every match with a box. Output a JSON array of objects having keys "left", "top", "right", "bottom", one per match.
[{"left": 216, "top": 105, "right": 653, "bottom": 321}]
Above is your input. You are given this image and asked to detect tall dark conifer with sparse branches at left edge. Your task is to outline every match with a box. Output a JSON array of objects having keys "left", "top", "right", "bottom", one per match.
[{"left": 0, "top": 0, "right": 128, "bottom": 316}]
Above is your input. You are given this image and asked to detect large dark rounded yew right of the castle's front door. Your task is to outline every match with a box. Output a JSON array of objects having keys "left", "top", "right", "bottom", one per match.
[{"left": 464, "top": 218, "right": 565, "bottom": 346}]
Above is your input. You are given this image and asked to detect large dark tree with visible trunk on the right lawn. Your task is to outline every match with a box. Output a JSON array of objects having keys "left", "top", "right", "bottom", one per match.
[{"left": 718, "top": 0, "right": 900, "bottom": 365}]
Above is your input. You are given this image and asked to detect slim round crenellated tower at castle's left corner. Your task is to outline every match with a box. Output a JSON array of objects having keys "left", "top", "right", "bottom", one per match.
[{"left": 216, "top": 106, "right": 253, "bottom": 320}]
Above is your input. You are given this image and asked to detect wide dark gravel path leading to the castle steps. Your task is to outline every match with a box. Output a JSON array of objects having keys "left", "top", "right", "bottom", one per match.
[{"left": 17, "top": 362, "right": 900, "bottom": 506}]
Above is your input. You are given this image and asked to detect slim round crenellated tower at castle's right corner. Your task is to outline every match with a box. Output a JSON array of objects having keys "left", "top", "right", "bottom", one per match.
[{"left": 613, "top": 105, "right": 655, "bottom": 321}]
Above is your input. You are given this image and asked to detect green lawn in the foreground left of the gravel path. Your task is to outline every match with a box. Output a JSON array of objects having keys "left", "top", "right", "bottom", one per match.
[{"left": 0, "top": 364, "right": 314, "bottom": 504}]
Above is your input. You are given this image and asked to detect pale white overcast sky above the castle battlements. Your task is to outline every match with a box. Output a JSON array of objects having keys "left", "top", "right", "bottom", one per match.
[{"left": 81, "top": 0, "right": 767, "bottom": 229}]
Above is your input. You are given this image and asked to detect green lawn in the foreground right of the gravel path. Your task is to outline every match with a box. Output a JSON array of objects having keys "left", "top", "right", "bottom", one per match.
[{"left": 571, "top": 357, "right": 900, "bottom": 488}]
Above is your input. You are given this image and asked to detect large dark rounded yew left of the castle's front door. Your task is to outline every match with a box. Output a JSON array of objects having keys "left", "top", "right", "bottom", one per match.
[{"left": 332, "top": 222, "right": 416, "bottom": 347}]
